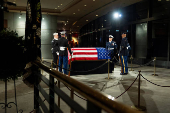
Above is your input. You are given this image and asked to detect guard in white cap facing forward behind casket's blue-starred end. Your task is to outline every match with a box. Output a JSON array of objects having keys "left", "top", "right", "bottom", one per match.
[{"left": 106, "top": 35, "right": 117, "bottom": 67}]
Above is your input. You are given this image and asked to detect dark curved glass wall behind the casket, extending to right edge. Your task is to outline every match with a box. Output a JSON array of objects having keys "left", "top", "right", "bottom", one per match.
[{"left": 80, "top": 0, "right": 170, "bottom": 66}]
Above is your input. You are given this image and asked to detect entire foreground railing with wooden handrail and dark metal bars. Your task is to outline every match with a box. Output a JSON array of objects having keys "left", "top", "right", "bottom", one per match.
[{"left": 33, "top": 61, "right": 140, "bottom": 113}]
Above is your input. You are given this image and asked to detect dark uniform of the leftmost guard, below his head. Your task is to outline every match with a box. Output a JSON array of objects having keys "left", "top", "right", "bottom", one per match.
[{"left": 51, "top": 38, "right": 59, "bottom": 68}]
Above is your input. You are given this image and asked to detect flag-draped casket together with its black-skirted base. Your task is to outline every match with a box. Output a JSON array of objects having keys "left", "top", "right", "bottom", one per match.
[{"left": 68, "top": 47, "right": 114, "bottom": 75}]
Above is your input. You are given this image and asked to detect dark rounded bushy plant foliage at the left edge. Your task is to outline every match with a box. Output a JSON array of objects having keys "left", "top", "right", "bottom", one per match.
[{"left": 0, "top": 30, "right": 26, "bottom": 81}]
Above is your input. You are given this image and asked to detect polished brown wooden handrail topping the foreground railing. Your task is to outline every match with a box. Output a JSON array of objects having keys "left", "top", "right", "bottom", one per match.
[{"left": 32, "top": 61, "right": 142, "bottom": 113}]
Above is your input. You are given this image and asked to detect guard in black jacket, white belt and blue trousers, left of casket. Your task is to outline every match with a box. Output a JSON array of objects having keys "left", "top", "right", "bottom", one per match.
[{"left": 58, "top": 31, "right": 72, "bottom": 75}]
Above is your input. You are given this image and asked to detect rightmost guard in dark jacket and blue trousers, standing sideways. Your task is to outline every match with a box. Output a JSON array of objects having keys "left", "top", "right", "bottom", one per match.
[{"left": 119, "top": 32, "right": 131, "bottom": 75}]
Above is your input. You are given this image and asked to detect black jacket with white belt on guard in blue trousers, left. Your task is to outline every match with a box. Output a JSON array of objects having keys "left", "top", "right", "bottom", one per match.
[{"left": 58, "top": 37, "right": 72, "bottom": 56}]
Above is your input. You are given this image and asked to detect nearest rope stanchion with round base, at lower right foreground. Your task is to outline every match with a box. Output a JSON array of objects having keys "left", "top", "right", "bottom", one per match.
[{"left": 132, "top": 71, "right": 146, "bottom": 111}]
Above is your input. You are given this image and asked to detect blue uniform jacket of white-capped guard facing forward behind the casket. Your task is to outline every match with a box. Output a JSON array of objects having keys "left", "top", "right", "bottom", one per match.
[{"left": 106, "top": 41, "right": 117, "bottom": 57}]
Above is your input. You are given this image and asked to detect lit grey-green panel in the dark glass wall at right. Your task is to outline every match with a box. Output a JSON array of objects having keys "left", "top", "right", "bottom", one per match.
[{"left": 135, "top": 23, "right": 147, "bottom": 58}]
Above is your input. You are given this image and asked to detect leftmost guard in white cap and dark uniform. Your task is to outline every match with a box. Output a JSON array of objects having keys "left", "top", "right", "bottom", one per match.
[{"left": 51, "top": 33, "right": 59, "bottom": 69}]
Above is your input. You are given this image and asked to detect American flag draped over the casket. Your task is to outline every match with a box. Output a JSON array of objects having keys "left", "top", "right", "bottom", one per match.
[{"left": 68, "top": 48, "right": 110, "bottom": 62}]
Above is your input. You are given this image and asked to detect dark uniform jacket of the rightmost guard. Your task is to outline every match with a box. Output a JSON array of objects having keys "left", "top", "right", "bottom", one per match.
[{"left": 119, "top": 37, "right": 128, "bottom": 56}]
